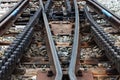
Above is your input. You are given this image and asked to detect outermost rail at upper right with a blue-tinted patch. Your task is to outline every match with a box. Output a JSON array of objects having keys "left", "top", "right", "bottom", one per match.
[{"left": 87, "top": 0, "right": 120, "bottom": 31}]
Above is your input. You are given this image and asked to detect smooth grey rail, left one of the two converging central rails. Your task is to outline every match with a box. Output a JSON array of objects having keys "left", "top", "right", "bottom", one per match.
[{"left": 40, "top": 0, "right": 63, "bottom": 80}]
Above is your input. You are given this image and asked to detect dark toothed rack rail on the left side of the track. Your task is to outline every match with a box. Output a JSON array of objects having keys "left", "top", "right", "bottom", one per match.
[{"left": 0, "top": 4, "right": 42, "bottom": 80}]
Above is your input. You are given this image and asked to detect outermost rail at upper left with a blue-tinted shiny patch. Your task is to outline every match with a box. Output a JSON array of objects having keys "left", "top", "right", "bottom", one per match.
[{"left": 0, "top": 0, "right": 29, "bottom": 36}]
